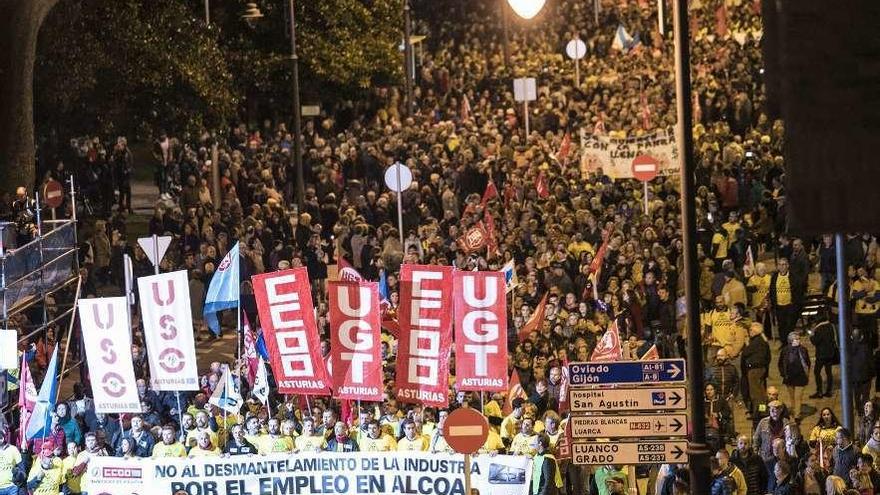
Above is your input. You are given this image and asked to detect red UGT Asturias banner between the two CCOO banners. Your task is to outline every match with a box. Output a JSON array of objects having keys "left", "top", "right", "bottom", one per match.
[{"left": 328, "top": 281, "right": 384, "bottom": 401}]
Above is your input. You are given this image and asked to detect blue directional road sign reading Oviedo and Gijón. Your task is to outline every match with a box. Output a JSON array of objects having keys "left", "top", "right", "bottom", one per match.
[{"left": 568, "top": 359, "right": 685, "bottom": 386}]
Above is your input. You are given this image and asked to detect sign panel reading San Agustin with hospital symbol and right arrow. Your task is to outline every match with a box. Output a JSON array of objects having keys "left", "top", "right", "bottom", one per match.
[{"left": 568, "top": 387, "right": 687, "bottom": 414}]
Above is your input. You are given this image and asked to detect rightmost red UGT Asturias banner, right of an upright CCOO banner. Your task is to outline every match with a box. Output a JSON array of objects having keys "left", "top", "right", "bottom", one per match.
[{"left": 455, "top": 271, "right": 507, "bottom": 392}]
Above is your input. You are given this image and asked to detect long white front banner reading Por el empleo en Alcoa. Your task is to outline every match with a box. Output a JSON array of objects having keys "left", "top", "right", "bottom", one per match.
[{"left": 88, "top": 452, "right": 532, "bottom": 495}]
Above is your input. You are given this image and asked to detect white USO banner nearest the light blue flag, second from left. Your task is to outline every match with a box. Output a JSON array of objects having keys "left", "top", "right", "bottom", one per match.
[{"left": 138, "top": 270, "right": 199, "bottom": 391}]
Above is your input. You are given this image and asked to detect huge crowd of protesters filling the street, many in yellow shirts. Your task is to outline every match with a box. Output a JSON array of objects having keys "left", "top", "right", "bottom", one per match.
[{"left": 0, "top": 0, "right": 880, "bottom": 495}]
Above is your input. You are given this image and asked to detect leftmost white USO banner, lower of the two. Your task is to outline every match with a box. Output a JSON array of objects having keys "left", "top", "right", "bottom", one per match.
[{"left": 79, "top": 297, "right": 141, "bottom": 414}]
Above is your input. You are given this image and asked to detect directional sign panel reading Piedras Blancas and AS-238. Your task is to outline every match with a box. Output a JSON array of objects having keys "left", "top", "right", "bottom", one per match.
[{"left": 570, "top": 414, "right": 687, "bottom": 439}]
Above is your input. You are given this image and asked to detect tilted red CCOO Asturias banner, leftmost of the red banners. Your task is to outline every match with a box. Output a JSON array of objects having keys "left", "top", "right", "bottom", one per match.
[{"left": 251, "top": 267, "right": 330, "bottom": 395}]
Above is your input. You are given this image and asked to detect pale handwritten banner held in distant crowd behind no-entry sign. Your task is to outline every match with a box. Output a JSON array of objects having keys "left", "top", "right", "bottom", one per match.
[{"left": 581, "top": 130, "right": 679, "bottom": 179}]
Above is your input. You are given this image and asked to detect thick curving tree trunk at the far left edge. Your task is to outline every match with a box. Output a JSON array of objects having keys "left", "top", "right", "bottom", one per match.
[{"left": 0, "top": 0, "right": 57, "bottom": 190}]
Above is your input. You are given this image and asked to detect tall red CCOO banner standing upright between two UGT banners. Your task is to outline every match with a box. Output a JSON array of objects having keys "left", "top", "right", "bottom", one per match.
[{"left": 395, "top": 265, "right": 453, "bottom": 407}]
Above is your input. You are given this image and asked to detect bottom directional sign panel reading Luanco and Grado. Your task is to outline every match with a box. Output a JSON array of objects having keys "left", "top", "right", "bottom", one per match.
[{"left": 572, "top": 440, "right": 687, "bottom": 466}]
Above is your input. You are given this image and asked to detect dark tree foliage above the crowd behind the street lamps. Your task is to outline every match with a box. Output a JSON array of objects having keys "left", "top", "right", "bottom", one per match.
[{"left": 35, "top": 0, "right": 402, "bottom": 140}]
